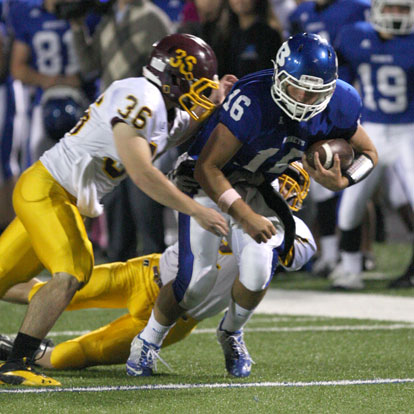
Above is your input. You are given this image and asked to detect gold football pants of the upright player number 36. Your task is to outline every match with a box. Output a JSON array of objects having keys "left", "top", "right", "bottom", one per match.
[{"left": 0, "top": 161, "right": 93, "bottom": 297}]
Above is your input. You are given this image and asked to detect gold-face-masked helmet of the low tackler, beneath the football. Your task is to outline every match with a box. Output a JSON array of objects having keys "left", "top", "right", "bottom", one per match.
[{"left": 278, "top": 161, "right": 310, "bottom": 211}]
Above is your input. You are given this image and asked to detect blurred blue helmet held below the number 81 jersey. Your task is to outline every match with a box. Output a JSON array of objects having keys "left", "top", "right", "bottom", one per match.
[{"left": 41, "top": 85, "right": 88, "bottom": 141}]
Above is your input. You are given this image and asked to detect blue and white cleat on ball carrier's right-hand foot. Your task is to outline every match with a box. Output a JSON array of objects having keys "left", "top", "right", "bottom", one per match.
[{"left": 217, "top": 315, "right": 253, "bottom": 378}]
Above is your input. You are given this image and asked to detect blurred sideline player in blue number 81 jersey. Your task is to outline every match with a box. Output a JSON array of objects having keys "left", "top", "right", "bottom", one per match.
[{"left": 9, "top": 0, "right": 92, "bottom": 167}]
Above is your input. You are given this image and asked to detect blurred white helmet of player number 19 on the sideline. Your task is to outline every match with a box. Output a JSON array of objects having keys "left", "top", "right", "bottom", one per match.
[{"left": 371, "top": 0, "right": 414, "bottom": 35}]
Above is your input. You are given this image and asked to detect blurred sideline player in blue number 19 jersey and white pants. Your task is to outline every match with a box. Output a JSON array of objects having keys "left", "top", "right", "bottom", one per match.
[{"left": 331, "top": 0, "right": 414, "bottom": 289}]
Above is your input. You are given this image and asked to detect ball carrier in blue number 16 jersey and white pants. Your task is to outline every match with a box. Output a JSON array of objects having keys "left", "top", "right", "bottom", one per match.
[{"left": 127, "top": 33, "right": 377, "bottom": 377}]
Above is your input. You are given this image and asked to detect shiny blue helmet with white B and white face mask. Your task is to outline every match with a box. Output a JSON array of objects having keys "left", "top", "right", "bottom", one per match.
[{"left": 271, "top": 33, "right": 338, "bottom": 121}]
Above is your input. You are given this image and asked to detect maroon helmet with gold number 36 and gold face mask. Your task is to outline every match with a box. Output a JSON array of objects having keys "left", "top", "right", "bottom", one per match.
[{"left": 143, "top": 33, "right": 219, "bottom": 121}]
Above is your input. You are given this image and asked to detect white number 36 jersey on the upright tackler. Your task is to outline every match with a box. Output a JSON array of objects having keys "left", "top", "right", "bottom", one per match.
[{"left": 40, "top": 77, "right": 169, "bottom": 217}]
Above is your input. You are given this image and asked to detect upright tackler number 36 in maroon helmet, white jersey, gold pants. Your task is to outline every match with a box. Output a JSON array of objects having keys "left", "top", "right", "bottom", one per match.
[{"left": 0, "top": 34, "right": 235, "bottom": 385}]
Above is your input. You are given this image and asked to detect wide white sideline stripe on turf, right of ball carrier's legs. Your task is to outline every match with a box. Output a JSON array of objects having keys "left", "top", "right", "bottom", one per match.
[{"left": 255, "top": 289, "right": 414, "bottom": 322}]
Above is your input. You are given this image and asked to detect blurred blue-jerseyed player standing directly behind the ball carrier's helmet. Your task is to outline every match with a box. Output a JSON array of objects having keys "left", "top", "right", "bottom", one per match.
[{"left": 289, "top": 0, "right": 370, "bottom": 277}]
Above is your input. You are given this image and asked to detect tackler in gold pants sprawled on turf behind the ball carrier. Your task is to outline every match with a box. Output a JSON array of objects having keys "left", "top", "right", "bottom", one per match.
[{"left": 0, "top": 165, "right": 316, "bottom": 369}]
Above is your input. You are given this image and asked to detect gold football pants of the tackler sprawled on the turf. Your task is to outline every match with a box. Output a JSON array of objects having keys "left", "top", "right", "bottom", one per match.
[{"left": 29, "top": 254, "right": 197, "bottom": 369}]
